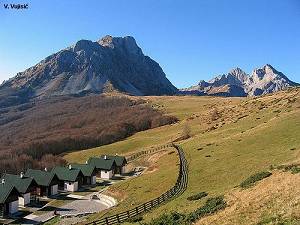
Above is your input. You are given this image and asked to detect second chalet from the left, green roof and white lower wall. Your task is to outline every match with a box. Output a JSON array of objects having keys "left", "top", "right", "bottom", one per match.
[{"left": 2, "top": 173, "right": 37, "bottom": 206}]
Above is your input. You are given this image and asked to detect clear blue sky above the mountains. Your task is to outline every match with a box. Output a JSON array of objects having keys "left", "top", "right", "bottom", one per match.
[{"left": 0, "top": 0, "right": 300, "bottom": 87}]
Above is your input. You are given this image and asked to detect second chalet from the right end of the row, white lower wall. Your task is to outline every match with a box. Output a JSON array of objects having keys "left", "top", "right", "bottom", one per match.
[{"left": 88, "top": 157, "right": 116, "bottom": 179}]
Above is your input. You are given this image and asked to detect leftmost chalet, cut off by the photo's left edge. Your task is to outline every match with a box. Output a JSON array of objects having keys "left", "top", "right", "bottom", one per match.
[{"left": 0, "top": 179, "right": 19, "bottom": 218}]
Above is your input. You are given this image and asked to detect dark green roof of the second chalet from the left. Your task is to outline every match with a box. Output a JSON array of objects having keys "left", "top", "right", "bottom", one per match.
[{"left": 2, "top": 174, "right": 34, "bottom": 194}]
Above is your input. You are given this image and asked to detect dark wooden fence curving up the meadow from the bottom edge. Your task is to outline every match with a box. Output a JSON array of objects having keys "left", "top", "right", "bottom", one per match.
[{"left": 88, "top": 144, "right": 188, "bottom": 225}]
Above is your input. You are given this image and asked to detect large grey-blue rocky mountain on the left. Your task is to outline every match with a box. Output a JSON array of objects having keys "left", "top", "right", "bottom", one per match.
[{"left": 0, "top": 36, "right": 177, "bottom": 103}]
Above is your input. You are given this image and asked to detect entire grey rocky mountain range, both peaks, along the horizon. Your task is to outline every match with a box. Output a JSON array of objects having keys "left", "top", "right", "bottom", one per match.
[{"left": 0, "top": 35, "right": 297, "bottom": 107}]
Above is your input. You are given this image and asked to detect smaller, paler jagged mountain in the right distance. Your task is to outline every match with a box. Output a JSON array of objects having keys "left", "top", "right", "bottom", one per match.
[{"left": 181, "top": 64, "right": 298, "bottom": 97}]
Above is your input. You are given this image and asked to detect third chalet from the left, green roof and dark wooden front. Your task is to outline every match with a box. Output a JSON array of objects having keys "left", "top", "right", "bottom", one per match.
[{"left": 25, "top": 169, "right": 59, "bottom": 196}]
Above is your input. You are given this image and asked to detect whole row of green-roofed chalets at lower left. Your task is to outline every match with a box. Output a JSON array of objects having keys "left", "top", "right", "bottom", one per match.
[{"left": 0, "top": 155, "right": 127, "bottom": 218}]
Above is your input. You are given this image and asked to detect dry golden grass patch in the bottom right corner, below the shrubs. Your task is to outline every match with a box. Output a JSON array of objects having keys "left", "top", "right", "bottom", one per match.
[{"left": 197, "top": 171, "right": 300, "bottom": 225}]
